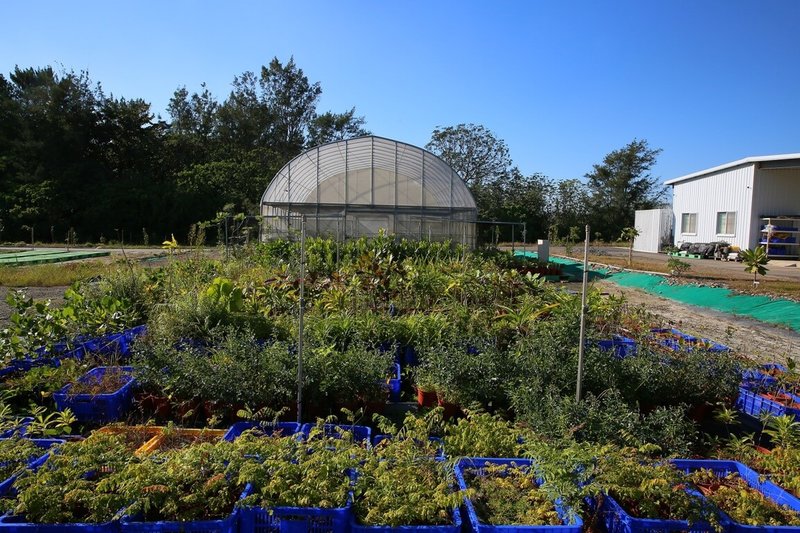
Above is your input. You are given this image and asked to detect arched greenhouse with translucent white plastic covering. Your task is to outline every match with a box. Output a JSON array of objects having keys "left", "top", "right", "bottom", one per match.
[{"left": 261, "top": 136, "right": 477, "bottom": 245}]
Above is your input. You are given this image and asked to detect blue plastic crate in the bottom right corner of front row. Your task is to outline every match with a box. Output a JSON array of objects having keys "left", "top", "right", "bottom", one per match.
[{"left": 671, "top": 459, "right": 800, "bottom": 533}]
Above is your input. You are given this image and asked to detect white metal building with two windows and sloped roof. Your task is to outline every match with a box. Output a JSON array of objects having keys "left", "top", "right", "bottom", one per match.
[{"left": 665, "top": 153, "right": 800, "bottom": 257}]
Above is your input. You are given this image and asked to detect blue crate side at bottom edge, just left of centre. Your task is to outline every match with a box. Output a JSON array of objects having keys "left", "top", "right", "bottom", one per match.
[{"left": 239, "top": 501, "right": 352, "bottom": 533}]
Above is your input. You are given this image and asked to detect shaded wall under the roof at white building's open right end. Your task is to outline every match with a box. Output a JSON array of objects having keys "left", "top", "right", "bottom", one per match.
[{"left": 751, "top": 168, "right": 800, "bottom": 246}]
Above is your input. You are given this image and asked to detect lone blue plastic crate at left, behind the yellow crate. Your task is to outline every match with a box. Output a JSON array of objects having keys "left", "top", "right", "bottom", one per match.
[{"left": 53, "top": 366, "right": 136, "bottom": 424}]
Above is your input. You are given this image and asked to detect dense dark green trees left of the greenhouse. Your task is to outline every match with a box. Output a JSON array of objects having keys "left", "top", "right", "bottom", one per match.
[{"left": 0, "top": 58, "right": 366, "bottom": 244}]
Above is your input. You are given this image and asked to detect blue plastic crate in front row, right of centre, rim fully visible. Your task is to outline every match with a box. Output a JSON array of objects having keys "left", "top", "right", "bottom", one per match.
[{"left": 455, "top": 457, "right": 583, "bottom": 533}]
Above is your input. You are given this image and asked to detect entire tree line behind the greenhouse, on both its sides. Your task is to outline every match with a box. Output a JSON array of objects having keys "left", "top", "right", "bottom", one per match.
[{"left": 0, "top": 58, "right": 663, "bottom": 244}]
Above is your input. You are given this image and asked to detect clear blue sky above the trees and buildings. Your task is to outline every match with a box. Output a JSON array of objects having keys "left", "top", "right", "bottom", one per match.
[{"left": 0, "top": 0, "right": 800, "bottom": 180}]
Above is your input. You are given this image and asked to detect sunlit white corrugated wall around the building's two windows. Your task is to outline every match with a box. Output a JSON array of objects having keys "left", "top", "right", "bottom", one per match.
[{"left": 672, "top": 163, "right": 758, "bottom": 248}]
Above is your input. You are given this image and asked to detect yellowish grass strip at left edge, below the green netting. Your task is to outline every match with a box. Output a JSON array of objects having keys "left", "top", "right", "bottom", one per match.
[{"left": 0, "top": 261, "right": 116, "bottom": 287}]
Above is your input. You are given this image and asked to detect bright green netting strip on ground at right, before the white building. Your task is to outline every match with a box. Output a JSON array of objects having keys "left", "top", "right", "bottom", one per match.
[{"left": 518, "top": 252, "right": 800, "bottom": 332}]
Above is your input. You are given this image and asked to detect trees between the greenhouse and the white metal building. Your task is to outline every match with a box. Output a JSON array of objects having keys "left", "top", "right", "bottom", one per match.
[{"left": 426, "top": 124, "right": 666, "bottom": 241}]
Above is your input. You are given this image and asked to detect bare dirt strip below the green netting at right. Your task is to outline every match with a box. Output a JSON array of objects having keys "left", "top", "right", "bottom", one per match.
[{"left": 594, "top": 281, "right": 800, "bottom": 363}]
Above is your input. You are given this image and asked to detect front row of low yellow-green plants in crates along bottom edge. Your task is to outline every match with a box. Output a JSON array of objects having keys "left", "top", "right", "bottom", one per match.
[{"left": 0, "top": 414, "right": 800, "bottom": 533}]
